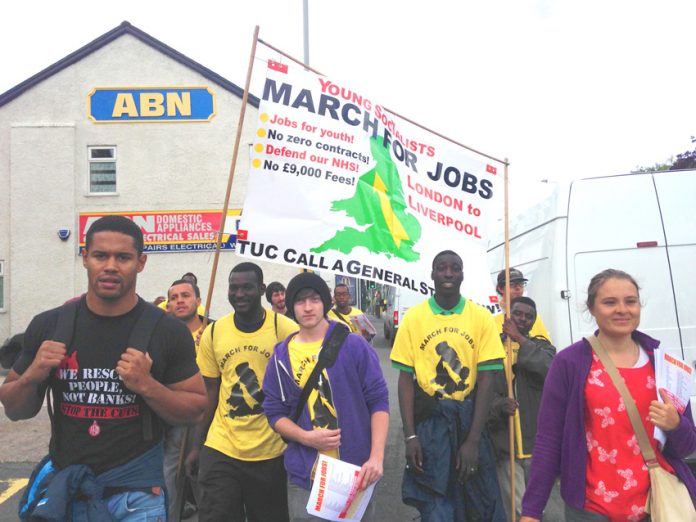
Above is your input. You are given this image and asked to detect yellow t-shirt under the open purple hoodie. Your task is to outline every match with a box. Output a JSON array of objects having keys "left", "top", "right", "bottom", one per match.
[{"left": 288, "top": 337, "right": 339, "bottom": 459}]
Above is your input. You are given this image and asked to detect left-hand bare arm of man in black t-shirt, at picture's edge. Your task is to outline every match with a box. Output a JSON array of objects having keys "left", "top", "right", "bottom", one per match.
[{"left": 0, "top": 341, "right": 66, "bottom": 421}]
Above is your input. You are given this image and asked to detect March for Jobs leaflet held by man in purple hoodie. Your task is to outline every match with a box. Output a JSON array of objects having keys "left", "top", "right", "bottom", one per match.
[{"left": 307, "top": 454, "right": 375, "bottom": 522}]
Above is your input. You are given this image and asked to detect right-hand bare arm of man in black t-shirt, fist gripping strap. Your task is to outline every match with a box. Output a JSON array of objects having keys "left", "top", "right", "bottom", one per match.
[{"left": 116, "top": 348, "right": 207, "bottom": 426}]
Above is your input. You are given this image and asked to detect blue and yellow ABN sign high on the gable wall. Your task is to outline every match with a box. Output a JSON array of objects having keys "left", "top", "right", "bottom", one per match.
[{"left": 87, "top": 87, "right": 215, "bottom": 123}]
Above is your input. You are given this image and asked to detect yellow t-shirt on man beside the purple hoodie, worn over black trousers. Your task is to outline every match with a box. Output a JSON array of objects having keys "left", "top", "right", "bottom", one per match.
[{"left": 196, "top": 310, "right": 298, "bottom": 460}]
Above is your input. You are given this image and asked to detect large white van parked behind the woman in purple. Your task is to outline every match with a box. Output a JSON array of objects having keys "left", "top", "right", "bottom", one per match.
[{"left": 489, "top": 170, "right": 696, "bottom": 366}]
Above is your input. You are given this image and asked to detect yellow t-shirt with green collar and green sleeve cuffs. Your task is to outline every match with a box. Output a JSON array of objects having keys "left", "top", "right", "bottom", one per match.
[{"left": 390, "top": 297, "right": 505, "bottom": 400}]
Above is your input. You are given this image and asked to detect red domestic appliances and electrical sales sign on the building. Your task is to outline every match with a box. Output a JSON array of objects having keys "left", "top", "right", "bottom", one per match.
[{"left": 78, "top": 209, "right": 241, "bottom": 254}]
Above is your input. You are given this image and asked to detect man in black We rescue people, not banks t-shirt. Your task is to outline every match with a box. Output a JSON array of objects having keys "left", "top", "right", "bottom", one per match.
[{"left": 0, "top": 216, "right": 206, "bottom": 520}]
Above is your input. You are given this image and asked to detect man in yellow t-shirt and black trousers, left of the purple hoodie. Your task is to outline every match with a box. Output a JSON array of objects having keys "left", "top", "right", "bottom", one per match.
[{"left": 187, "top": 262, "right": 297, "bottom": 522}]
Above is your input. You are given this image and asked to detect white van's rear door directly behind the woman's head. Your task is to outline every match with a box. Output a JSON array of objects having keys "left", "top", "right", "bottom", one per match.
[{"left": 567, "top": 174, "right": 679, "bottom": 347}]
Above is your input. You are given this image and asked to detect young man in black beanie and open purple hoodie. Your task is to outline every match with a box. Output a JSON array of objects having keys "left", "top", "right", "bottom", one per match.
[{"left": 263, "top": 272, "right": 389, "bottom": 521}]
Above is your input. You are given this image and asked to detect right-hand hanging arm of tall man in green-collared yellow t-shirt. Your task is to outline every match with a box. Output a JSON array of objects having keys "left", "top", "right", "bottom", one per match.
[{"left": 457, "top": 359, "right": 502, "bottom": 482}]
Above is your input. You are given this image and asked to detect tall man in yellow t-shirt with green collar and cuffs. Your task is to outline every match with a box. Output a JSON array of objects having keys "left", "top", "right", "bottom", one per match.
[{"left": 390, "top": 250, "right": 505, "bottom": 522}]
